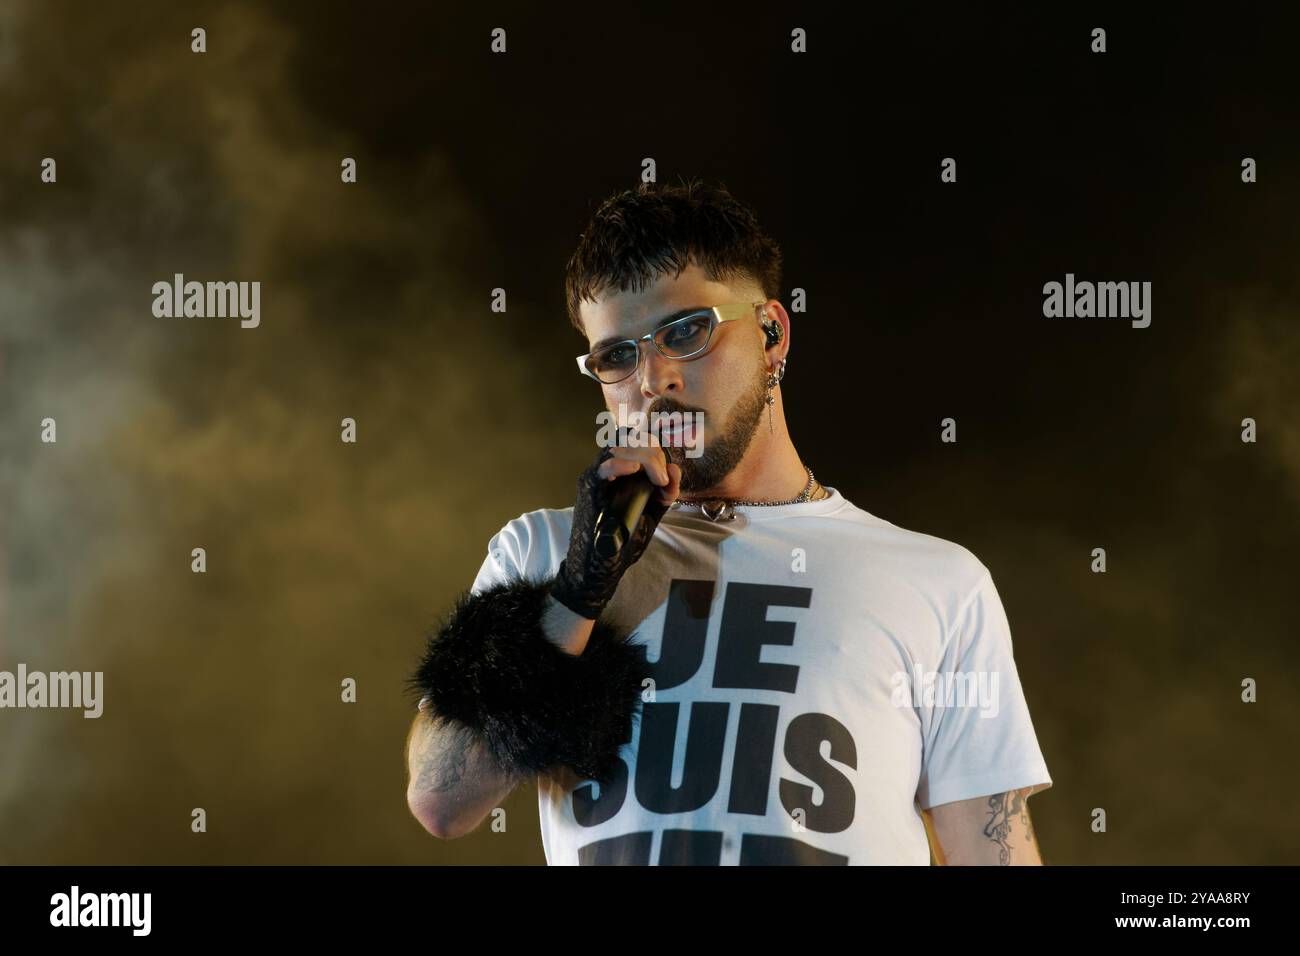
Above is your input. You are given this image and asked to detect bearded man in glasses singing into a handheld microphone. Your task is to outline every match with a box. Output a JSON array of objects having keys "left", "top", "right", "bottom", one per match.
[{"left": 407, "top": 182, "right": 1052, "bottom": 865}]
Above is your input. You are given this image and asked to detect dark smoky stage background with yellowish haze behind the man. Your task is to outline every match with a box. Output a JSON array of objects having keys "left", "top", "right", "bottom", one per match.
[{"left": 0, "top": 1, "right": 1300, "bottom": 864}]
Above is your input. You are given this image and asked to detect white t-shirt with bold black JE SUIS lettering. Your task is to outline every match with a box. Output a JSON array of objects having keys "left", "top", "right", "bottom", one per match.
[{"left": 472, "top": 488, "right": 1052, "bottom": 865}]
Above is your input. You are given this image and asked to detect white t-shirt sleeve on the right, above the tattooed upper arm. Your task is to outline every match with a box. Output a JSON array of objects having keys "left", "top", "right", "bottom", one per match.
[{"left": 917, "top": 568, "right": 1052, "bottom": 810}]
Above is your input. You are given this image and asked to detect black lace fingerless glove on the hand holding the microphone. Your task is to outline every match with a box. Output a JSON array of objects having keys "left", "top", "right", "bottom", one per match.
[{"left": 550, "top": 449, "right": 670, "bottom": 620}]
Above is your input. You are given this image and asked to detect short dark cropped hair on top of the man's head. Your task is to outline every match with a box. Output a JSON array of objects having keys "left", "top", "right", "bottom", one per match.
[{"left": 564, "top": 179, "right": 781, "bottom": 336}]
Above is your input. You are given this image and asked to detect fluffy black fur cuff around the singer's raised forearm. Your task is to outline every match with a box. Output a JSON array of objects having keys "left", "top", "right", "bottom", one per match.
[{"left": 408, "top": 579, "right": 650, "bottom": 786}]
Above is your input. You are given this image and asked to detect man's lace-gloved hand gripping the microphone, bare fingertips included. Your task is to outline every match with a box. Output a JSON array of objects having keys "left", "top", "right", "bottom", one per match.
[{"left": 551, "top": 433, "right": 681, "bottom": 620}]
